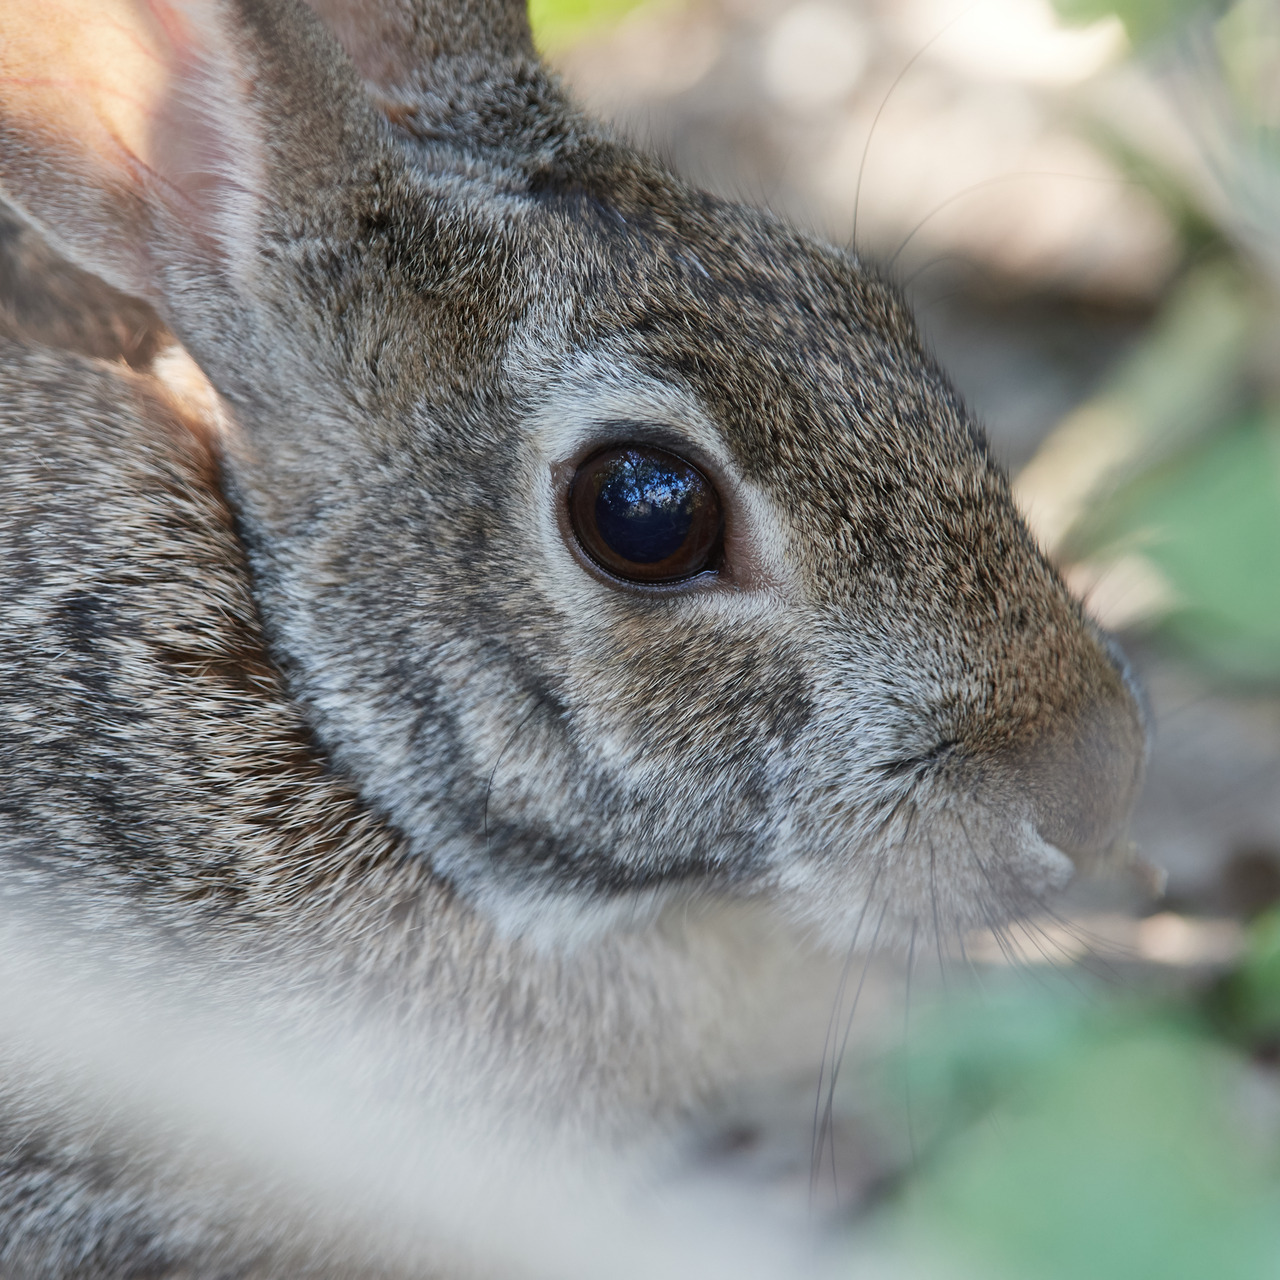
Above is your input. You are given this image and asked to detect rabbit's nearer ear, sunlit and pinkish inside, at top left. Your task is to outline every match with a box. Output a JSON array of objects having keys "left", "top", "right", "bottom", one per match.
[{"left": 0, "top": 0, "right": 376, "bottom": 302}]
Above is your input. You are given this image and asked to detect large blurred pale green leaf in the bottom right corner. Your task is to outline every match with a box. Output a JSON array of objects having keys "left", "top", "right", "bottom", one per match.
[{"left": 909, "top": 1024, "right": 1280, "bottom": 1280}]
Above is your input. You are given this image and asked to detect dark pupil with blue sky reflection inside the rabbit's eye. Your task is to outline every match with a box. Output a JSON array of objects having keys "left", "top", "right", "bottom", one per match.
[{"left": 595, "top": 453, "right": 703, "bottom": 564}]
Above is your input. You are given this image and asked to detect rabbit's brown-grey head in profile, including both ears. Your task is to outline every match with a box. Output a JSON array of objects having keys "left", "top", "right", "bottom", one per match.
[{"left": 0, "top": 0, "right": 1146, "bottom": 941}]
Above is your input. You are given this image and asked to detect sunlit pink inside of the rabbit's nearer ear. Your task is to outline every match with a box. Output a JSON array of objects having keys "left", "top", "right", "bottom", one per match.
[{"left": 0, "top": 0, "right": 264, "bottom": 296}]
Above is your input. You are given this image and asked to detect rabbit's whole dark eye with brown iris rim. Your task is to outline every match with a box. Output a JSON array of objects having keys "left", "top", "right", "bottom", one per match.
[{"left": 568, "top": 444, "right": 722, "bottom": 582}]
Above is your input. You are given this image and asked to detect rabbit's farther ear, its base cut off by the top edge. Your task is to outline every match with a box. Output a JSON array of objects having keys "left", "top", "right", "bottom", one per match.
[{"left": 307, "top": 0, "right": 535, "bottom": 101}]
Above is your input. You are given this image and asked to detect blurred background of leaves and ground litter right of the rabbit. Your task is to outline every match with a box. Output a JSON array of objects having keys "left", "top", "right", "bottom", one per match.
[{"left": 532, "top": 0, "right": 1280, "bottom": 1280}]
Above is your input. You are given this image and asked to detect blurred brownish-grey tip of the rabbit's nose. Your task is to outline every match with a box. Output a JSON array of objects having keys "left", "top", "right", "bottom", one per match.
[{"left": 1019, "top": 654, "right": 1147, "bottom": 863}]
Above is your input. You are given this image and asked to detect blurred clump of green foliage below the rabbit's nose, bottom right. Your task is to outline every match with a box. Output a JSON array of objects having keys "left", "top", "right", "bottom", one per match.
[{"left": 879, "top": 916, "right": 1280, "bottom": 1280}]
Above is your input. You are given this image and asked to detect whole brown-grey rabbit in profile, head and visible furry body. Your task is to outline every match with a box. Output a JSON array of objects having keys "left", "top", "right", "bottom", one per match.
[{"left": 0, "top": 0, "right": 1147, "bottom": 1277}]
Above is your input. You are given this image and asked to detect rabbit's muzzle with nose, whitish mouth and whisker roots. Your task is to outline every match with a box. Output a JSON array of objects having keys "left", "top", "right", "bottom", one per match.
[{"left": 778, "top": 596, "right": 1148, "bottom": 945}]
